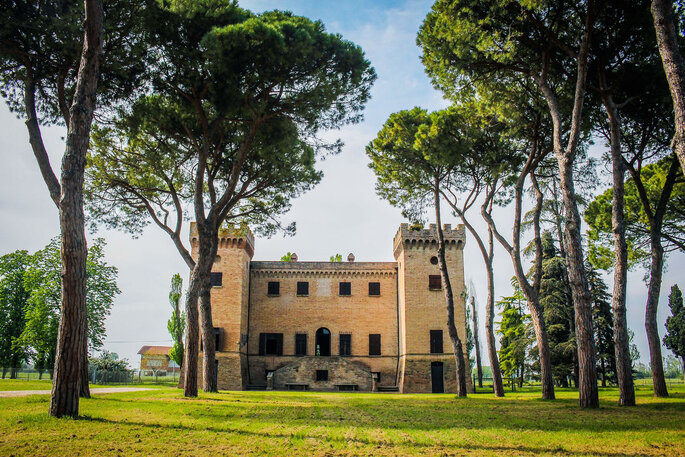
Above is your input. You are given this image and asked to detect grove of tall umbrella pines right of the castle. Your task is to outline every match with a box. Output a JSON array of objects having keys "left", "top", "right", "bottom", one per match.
[{"left": 367, "top": 0, "right": 685, "bottom": 407}]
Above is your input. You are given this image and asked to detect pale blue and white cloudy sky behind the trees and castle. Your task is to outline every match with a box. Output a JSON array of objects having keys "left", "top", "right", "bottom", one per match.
[{"left": 0, "top": 0, "right": 685, "bottom": 367}]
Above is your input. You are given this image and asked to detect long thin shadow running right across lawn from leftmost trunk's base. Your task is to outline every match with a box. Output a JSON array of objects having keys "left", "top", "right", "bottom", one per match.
[{"left": 80, "top": 416, "right": 651, "bottom": 457}]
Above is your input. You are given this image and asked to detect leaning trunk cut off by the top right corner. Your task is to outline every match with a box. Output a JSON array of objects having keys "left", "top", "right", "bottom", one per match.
[{"left": 651, "top": 0, "right": 685, "bottom": 173}]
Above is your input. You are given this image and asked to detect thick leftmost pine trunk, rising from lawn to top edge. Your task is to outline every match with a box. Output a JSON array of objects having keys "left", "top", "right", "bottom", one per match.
[{"left": 50, "top": 0, "right": 103, "bottom": 417}]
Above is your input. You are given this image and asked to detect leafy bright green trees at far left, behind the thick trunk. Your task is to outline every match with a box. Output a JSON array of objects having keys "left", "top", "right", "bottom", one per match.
[{"left": 0, "top": 238, "right": 120, "bottom": 378}]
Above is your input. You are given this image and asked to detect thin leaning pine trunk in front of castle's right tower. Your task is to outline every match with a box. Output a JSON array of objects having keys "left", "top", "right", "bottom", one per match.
[{"left": 433, "top": 176, "right": 466, "bottom": 397}]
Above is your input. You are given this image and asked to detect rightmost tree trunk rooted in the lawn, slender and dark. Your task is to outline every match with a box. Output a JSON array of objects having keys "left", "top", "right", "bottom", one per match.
[{"left": 645, "top": 228, "right": 668, "bottom": 397}]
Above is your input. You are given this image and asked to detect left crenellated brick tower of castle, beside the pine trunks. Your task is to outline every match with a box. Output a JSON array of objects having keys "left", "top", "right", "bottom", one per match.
[{"left": 190, "top": 222, "right": 254, "bottom": 390}]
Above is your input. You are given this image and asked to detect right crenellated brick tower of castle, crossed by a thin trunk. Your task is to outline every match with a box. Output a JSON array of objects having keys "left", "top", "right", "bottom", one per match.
[{"left": 393, "top": 223, "right": 472, "bottom": 393}]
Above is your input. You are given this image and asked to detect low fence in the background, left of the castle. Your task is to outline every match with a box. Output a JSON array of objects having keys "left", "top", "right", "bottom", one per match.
[{"left": 0, "top": 366, "right": 180, "bottom": 385}]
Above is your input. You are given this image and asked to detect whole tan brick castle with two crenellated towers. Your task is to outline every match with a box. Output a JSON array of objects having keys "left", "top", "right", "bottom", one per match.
[{"left": 190, "top": 224, "right": 472, "bottom": 392}]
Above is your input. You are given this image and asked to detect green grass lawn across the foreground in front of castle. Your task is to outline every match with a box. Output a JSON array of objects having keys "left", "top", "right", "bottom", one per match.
[{"left": 0, "top": 387, "right": 685, "bottom": 456}]
